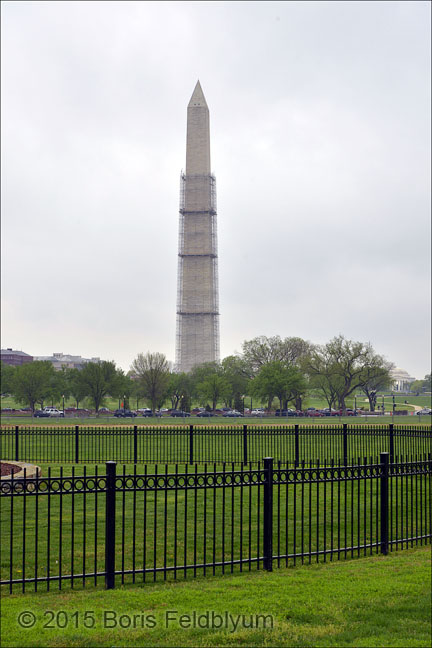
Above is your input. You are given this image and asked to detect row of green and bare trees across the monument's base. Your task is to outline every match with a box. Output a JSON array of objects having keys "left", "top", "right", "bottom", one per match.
[{"left": 1, "top": 335, "right": 422, "bottom": 412}]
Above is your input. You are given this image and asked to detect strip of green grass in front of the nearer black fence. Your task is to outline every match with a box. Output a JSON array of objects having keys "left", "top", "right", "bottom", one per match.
[{"left": 1, "top": 547, "right": 432, "bottom": 648}]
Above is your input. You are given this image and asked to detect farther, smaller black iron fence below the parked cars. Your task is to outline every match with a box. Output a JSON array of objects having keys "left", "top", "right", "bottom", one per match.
[{"left": 0, "top": 424, "right": 432, "bottom": 465}]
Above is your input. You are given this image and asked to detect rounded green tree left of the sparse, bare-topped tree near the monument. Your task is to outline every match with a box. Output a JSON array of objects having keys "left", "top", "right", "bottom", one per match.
[{"left": 76, "top": 360, "right": 121, "bottom": 414}]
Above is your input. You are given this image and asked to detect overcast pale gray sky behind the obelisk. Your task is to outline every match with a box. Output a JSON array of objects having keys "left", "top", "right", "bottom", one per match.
[{"left": 1, "top": 1, "right": 431, "bottom": 377}]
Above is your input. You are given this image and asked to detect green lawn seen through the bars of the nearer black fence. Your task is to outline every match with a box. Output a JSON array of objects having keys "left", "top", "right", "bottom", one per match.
[{"left": 0, "top": 458, "right": 431, "bottom": 592}]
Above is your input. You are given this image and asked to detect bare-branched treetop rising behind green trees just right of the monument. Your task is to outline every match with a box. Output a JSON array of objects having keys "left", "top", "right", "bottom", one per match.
[{"left": 242, "top": 335, "right": 312, "bottom": 373}]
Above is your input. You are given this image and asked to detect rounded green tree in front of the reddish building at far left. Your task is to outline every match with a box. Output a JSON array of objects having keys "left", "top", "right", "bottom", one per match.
[{"left": 11, "top": 361, "right": 55, "bottom": 412}]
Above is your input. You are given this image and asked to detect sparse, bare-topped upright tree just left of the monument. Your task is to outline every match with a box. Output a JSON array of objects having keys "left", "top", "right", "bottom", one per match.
[{"left": 131, "top": 352, "right": 170, "bottom": 411}]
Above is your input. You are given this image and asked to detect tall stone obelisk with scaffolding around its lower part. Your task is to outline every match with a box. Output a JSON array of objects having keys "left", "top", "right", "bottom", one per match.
[{"left": 176, "top": 81, "right": 219, "bottom": 371}]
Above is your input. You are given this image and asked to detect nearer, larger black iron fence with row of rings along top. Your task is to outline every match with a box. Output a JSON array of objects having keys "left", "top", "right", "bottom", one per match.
[{"left": 0, "top": 453, "right": 432, "bottom": 592}]
